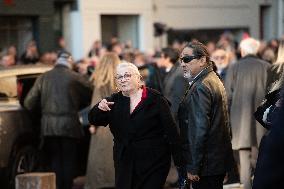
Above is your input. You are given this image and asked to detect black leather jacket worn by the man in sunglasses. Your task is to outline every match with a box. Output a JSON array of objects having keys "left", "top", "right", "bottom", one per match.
[{"left": 178, "top": 67, "right": 233, "bottom": 176}]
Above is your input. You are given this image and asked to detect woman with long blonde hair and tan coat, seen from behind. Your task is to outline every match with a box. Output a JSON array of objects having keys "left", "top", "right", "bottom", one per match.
[{"left": 85, "top": 53, "right": 120, "bottom": 189}]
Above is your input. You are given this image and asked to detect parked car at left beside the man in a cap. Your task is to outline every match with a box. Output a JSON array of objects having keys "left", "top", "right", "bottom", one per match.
[{"left": 0, "top": 65, "right": 52, "bottom": 188}]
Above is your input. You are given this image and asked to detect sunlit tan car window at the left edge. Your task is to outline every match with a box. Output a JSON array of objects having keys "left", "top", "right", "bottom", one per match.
[{"left": 0, "top": 76, "right": 17, "bottom": 100}]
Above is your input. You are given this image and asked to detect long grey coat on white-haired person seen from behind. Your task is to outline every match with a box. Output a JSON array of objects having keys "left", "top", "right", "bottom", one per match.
[{"left": 225, "top": 55, "right": 270, "bottom": 150}]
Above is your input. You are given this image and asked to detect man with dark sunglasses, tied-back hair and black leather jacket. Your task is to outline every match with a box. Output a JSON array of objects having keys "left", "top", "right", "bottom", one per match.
[{"left": 178, "top": 42, "right": 233, "bottom": 189}]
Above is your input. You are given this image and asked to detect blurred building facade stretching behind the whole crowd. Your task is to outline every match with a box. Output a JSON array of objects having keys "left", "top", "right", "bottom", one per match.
[{"left": 0, "top": 0, "right": 284, "bottom": 59}]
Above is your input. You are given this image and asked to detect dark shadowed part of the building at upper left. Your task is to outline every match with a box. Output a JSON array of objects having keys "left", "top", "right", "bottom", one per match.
[{"left": 0, "top": 0, "right": 76, "bottom": 54}]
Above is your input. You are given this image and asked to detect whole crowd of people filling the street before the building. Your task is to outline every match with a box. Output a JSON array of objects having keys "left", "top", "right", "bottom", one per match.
[{"left": 0, "top": 33, "right": 284, "bottom": 189}]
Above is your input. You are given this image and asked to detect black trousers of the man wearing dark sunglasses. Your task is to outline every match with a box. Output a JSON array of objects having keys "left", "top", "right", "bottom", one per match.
[{"left": 192, "top": 174, "right": 225, "bottom": 189}]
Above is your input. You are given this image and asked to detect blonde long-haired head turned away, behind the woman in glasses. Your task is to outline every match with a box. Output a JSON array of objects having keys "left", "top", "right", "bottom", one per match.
[{"left": 92, "top": 52, "right": 120, "bottom": 91}]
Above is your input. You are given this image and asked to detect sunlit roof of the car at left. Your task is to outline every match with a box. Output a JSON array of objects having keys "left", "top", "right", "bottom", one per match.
[{"left": 0, "top": 64, "right": 53, "bottom": 78}]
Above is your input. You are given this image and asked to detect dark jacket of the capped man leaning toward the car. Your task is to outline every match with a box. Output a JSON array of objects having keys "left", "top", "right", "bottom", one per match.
[{"left": 24, "top": 65, "right": 92, "bottom": 138}]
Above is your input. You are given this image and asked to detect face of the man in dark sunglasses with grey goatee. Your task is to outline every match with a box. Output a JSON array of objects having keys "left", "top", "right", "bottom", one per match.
[{"left": 180, "top": 47, "right": 204, "bottom": 79}]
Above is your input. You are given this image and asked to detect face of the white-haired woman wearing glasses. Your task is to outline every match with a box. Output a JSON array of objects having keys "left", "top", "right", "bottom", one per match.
[{"left": 115, "top": 67, "right": 140, "bottom": 93}]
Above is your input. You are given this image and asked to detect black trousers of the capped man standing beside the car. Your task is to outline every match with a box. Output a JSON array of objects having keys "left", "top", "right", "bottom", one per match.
[{"left": 43, "top": 137, "right": 79, "bottom": 189}]
